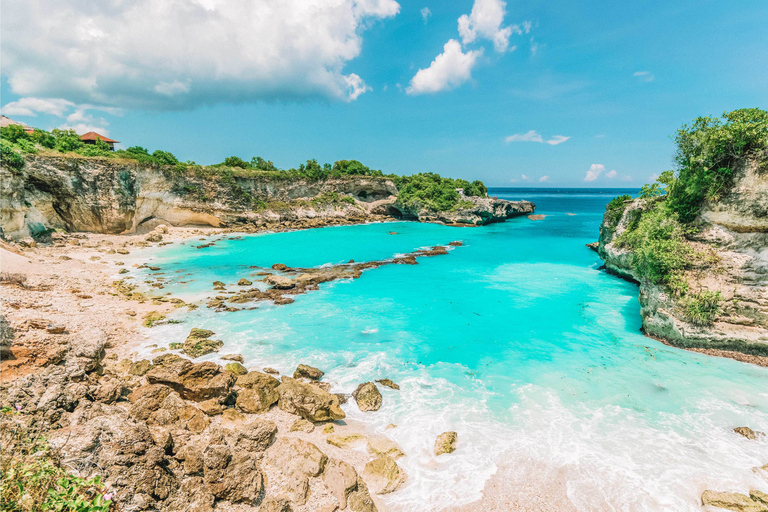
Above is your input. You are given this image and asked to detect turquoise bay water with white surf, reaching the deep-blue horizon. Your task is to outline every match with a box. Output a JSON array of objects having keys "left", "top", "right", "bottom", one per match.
[{"left": 129, "top": 189, "right": 768, "bottom": 511}]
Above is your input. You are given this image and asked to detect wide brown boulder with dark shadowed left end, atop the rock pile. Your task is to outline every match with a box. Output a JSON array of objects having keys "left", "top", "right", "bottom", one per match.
[{"left": 146, "top": 360, "right": 235, "bottom": 402}]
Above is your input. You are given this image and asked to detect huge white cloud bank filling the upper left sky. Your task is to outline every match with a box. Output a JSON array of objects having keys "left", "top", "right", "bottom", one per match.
[{"left": 0, "top": 0, "right": 400, "bottom": 109}]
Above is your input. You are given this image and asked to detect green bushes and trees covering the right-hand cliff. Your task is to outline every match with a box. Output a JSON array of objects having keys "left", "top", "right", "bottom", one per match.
[{"left": 606, "top": 108, "right": 768, "bottom": 325}]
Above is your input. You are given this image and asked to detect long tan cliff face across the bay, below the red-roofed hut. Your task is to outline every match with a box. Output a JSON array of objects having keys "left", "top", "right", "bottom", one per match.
[{"left": 0, "top": 155, "right": 534, "bottom": 239}]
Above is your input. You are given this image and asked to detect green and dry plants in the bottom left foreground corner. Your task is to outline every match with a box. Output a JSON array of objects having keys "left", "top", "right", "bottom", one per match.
[{"left": 0, "top": 424, "right": 112, "bottom": 512}]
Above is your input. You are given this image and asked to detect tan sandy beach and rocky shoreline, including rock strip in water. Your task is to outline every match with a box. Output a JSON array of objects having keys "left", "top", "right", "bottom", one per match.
[{"left": 0, "top": 228, "right": 460, "bottom": 512}]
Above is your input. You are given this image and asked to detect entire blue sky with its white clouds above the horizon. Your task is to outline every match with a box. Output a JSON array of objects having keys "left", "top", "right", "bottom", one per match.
[{"left": 0, "top": 0, "right": 768, "bottom": 187}]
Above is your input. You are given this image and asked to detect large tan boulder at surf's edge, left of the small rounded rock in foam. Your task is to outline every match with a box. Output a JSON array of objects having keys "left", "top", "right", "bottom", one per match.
[{"left": 277, "top": 377, "right": 346, "bottom": 422}]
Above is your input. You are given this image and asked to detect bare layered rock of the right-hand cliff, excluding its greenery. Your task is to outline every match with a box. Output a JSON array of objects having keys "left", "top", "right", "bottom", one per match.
[{"left": 597, "top": 158, "right": 768, "bottom": 355}]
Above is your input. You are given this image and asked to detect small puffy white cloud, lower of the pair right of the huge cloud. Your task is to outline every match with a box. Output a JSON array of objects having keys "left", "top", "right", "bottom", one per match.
[{"left": 406, "top": 39, "right": 483, "bottom": 95}]
